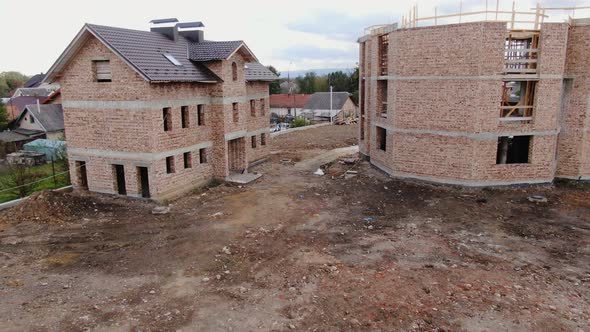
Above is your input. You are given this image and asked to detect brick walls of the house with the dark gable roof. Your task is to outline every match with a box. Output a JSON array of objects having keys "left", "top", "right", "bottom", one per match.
[{"left": 60, "top": 36, "right": 270, "bottom": 200}]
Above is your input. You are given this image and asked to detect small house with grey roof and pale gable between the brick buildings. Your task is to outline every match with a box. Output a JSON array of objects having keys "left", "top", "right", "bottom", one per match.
[{"left": 301, "top": 92, "right": 357, "bottom": 121}]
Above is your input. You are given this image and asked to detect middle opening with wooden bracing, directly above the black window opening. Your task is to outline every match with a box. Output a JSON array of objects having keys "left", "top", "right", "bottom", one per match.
[{"left": 500, "top": 81, "right": 537, "bottom": 121}]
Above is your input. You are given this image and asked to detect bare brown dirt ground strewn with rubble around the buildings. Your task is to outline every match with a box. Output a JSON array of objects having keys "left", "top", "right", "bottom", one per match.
[{"left": 0, "top": 126, "right": 590, "bottom": 331}]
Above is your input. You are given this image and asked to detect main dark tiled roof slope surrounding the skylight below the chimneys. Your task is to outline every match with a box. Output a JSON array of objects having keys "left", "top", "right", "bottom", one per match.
[{"left": 87, "top": 24, "right": 220, "bottom": 82}]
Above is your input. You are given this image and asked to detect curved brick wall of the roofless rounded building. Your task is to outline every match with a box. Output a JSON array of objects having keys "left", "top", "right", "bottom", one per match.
[{"left": 360, "top": 22, "right": 568, "bottom": 185}]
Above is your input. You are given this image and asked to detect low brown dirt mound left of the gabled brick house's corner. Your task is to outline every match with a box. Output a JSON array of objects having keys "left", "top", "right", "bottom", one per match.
[{"left": 0, "top": 191, "right": 117, "bottom": 223}]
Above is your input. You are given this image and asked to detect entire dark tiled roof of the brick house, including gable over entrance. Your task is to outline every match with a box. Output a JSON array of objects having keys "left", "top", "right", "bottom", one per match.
[{"left": 44, "top": 24, "right": 276, "bottom": 83}]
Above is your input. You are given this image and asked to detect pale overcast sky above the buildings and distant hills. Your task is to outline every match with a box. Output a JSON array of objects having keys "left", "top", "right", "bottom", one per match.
[{"left": 0, "top": 0, "right": 590, "bottom": 75}]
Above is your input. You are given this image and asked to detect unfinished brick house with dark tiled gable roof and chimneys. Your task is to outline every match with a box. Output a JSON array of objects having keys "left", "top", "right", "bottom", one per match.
[{"left": 44, "top": 19, "right": 277, "bottom": 200}]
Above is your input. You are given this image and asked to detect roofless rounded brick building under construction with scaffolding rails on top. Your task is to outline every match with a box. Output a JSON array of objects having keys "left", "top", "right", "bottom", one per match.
[{"left": 359, "top": 10, "right": 590, "bottom": 186}]
